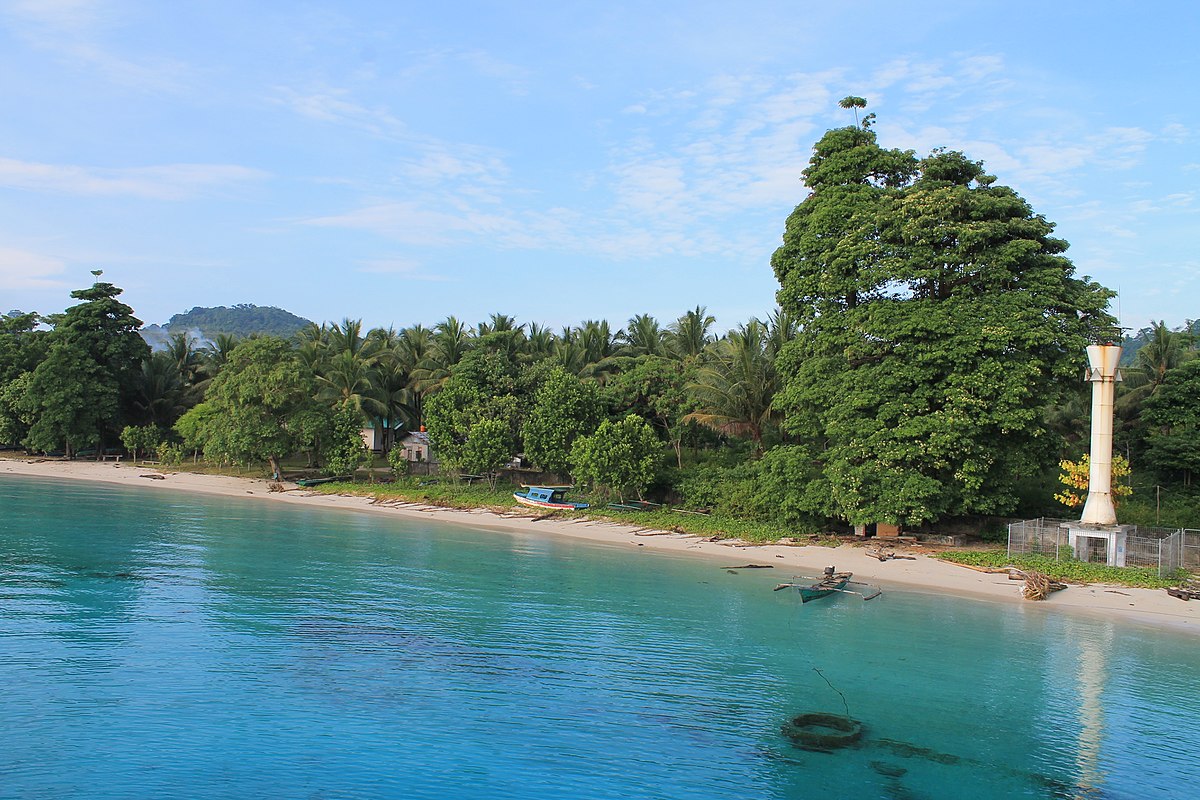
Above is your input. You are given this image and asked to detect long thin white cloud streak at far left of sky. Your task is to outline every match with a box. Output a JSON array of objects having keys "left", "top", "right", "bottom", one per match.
[{"left": 0, "top": 158, "right": 266, "bottom": 200}]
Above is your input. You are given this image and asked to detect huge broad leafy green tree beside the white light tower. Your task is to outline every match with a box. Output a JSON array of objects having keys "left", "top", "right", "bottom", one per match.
[{"left": 772, "top": 120, "right": 1116, "bottom": 524}]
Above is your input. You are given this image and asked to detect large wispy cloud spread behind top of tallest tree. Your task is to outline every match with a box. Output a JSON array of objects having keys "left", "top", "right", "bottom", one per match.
[{"left": 287, "top": 54, "right": 1186, "bottom": 273}]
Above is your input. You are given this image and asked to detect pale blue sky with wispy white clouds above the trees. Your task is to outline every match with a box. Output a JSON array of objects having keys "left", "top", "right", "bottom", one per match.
[{"left": 0, "top": 0, "right": 1200, "bottom": 330}]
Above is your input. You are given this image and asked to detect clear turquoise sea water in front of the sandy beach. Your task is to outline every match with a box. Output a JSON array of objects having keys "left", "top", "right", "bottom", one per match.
[{"left": 0, "top": 477, "right": 1200, "bottom": 800}]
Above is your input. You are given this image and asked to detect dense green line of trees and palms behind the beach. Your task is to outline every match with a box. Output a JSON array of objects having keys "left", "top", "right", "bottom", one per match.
[{"left": 0, "top": 106, "right": 1200, "bottom": 529}]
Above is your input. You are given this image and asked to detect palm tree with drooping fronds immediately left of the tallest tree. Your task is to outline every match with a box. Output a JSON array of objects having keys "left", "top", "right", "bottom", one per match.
[{"left": 684, "top": 319, "right": 780, "bottom": 455}]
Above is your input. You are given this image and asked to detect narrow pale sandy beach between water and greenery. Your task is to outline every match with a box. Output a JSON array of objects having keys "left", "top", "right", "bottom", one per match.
[{"left": 0, "top": 458, "right": 1200, "bottom": 636}]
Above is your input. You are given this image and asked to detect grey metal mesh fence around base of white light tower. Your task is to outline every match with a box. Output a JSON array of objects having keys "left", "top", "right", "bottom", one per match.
[{"left": 1008, "top": 517, "right": 1200, "bottom": 577}]
